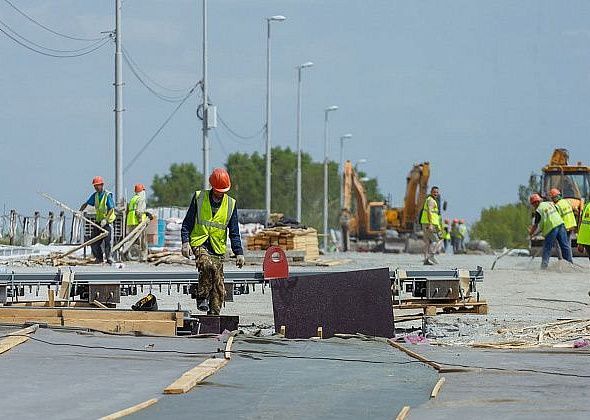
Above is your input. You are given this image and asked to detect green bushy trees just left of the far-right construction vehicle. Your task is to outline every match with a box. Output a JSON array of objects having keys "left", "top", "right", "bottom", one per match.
[{"left": 469, "top": 203, "right": 531, "bottom": 248}]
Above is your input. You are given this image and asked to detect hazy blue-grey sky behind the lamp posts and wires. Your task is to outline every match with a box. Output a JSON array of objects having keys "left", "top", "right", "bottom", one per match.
[{"left": 0, "top": 0, "right": 590, "bottom": 221}]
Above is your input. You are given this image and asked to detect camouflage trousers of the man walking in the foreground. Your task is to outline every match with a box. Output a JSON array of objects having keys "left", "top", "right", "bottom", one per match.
[{"left": 193, "top": 247, "right": 225, "bottom": 315}]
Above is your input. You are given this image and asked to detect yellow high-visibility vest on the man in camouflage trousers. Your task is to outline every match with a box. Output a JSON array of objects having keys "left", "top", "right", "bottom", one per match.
[{"left": 191, "top": 190, "right": 236, "bottom": 255}]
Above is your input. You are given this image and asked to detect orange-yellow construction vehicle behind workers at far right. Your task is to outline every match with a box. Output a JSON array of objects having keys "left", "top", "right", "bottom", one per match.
[{"left": 531, "top": 149, "right": 590, "bottom": 255}]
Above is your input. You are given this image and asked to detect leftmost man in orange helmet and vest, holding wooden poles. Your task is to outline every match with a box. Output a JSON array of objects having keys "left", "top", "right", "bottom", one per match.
[{"left": 80, "top": 176, "right": 117, "bottom": 264}]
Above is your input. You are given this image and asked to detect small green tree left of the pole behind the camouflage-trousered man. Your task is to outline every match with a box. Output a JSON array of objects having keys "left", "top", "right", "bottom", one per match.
[{"left": 148, "top": 163, "right": 203, "bottom": 207}]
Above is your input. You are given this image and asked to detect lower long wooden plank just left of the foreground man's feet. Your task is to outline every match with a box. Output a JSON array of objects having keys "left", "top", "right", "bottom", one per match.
[{"left": 63, "top": 320, "right": 176, "bottom": 336}]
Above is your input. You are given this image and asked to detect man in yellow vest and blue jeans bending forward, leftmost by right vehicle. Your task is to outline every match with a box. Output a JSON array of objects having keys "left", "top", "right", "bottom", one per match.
[{"left": 529, "top": 193, "right": 573, "bottom": 269}]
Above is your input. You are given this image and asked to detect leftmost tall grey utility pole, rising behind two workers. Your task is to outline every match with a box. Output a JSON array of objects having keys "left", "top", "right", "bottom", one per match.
[{"left": 115, "top": 0, "right": 125, "bottom": 206}]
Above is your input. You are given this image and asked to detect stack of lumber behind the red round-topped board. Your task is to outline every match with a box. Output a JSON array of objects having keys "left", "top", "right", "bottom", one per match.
[{"left": 247, "top": 226, "right": 320, "bottom": 260}]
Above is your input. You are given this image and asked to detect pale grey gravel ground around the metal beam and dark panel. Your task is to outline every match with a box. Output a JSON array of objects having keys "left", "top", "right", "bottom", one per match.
[{"left": 8, "top": 253, "right": 590, "bottom": 343}]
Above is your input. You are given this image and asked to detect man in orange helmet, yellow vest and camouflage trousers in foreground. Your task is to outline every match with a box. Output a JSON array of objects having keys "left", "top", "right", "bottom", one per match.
[{"left": 181, "top": 168, "right": 245, "bottom": 315}]
